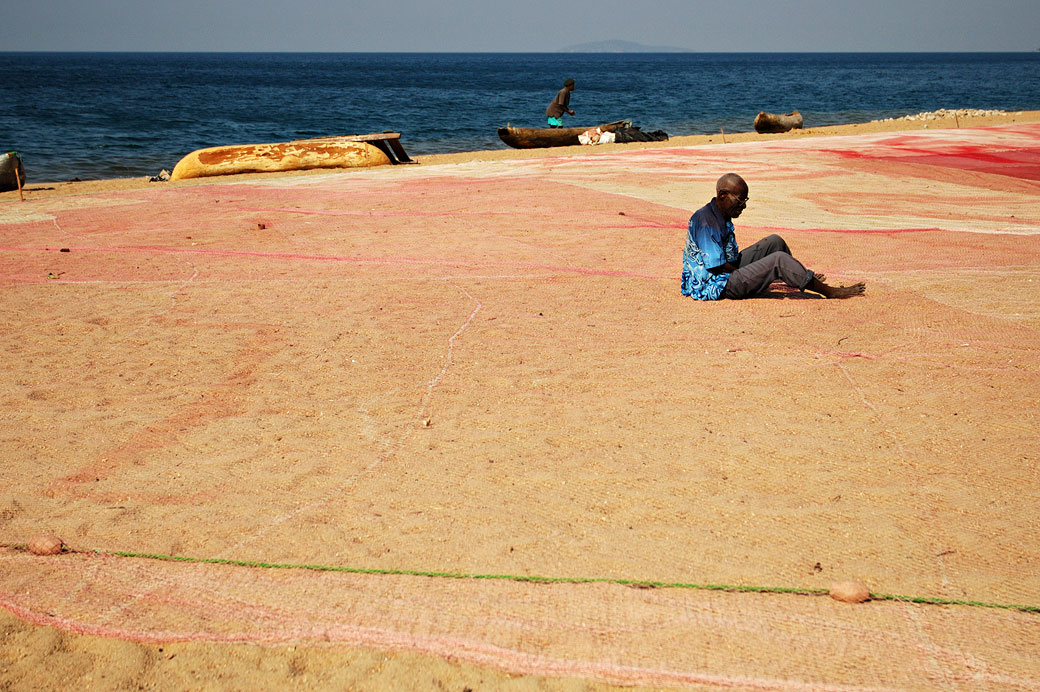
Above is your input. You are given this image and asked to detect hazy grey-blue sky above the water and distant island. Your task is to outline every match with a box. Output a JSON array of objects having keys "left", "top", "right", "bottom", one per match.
[{"left": 0, "top": 0, "right": 1040, "bottom": 52}]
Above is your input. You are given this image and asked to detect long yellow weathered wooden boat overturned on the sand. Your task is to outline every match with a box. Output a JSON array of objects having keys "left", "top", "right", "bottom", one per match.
[{"left": 170, "top": 132, "right": 414, "bottom": 180}]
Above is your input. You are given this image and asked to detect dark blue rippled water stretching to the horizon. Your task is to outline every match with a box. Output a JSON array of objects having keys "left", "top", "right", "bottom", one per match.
[{"left": 0, "top": 53, "right": 1040, "bottom": 182}]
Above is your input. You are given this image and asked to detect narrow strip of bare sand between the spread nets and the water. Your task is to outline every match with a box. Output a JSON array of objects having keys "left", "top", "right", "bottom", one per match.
[{"left": 0, "top": 110, "right": 1040, "bottom": 202}]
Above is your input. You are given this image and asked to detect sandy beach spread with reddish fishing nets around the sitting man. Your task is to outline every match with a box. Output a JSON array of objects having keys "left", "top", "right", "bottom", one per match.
[{"left": 6, "top": 111, "right": 1040, "bottom": 692}]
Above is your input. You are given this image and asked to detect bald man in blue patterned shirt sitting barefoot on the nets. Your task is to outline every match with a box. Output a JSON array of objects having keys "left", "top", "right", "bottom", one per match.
[{"left": 681, "top": 173, "right": 866, "bottom": 301}]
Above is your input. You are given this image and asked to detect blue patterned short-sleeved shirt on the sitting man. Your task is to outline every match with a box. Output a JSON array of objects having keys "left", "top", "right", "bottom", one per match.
[{"left": 681, "top": 199, "right": 740, "bottom": 301}]
